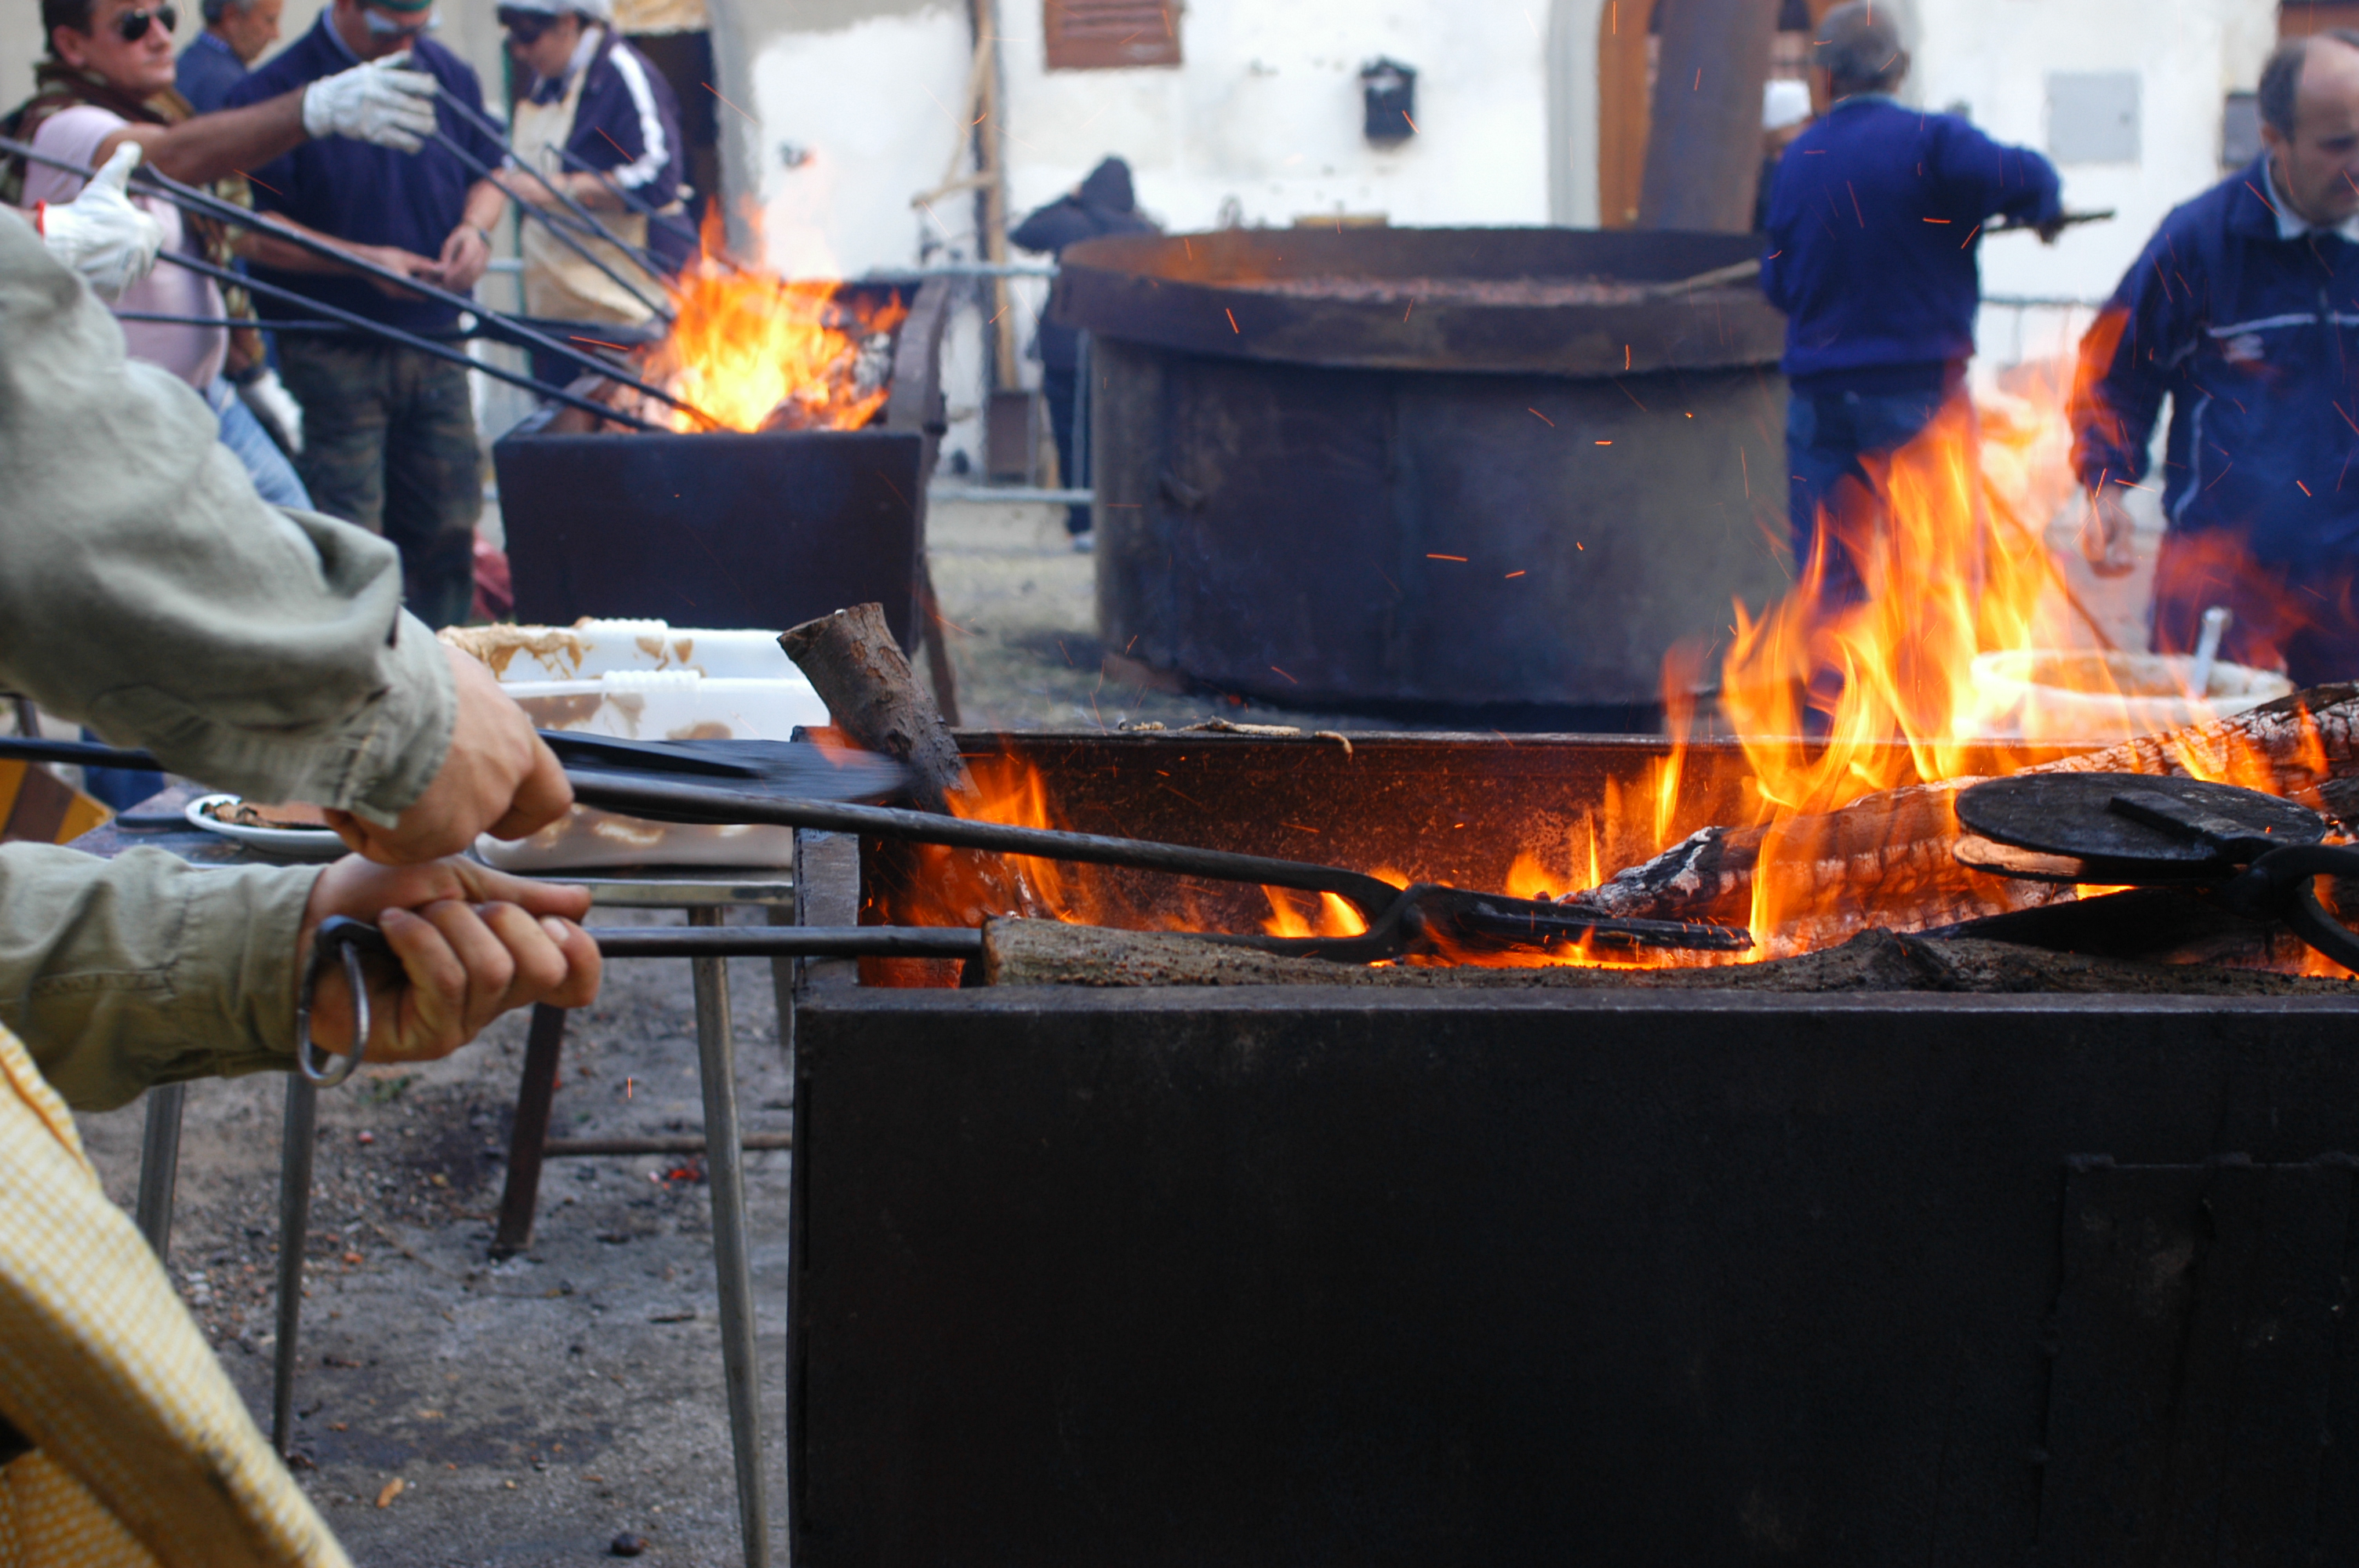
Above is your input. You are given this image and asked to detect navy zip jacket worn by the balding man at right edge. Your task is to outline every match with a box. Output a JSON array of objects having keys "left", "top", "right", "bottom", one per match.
[{"left": 2074, "top": 155, "right": 2359, "bottom": 566}]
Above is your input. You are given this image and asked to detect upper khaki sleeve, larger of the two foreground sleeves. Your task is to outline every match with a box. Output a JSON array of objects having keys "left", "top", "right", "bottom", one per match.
[{"left": 0, "top": 212, "right": 456, "bottom": 826}]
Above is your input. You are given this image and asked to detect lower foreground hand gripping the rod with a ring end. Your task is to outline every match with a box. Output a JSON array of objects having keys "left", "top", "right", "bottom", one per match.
[{"left": 295, "top": 856, "right": 599, "bottom": 1061}]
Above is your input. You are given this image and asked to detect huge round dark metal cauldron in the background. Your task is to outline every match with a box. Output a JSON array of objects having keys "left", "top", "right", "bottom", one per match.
[{"left": 1060, "top": 229, "right": 1788, "bottom": 721}]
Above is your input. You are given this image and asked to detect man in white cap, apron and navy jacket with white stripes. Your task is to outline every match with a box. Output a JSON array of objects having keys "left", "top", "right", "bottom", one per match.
[{"left": 500, "top": 0, "right": 691, "bottom": 379}]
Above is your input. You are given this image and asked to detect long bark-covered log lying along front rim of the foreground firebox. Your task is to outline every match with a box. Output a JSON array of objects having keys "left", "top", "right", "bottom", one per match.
[{"left": 983, "top": 920, "right": 2350, "bottom": 995}]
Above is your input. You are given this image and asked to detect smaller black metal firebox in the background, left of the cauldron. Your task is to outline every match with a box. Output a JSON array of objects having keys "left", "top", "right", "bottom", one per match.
[{"left": 491, "top": 281, "right": 948, "bottom": 648}]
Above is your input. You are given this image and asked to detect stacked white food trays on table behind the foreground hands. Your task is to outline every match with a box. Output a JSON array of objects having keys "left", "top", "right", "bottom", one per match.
[{"left": 451, "top": 620, "right": 828, "bottom": 873}]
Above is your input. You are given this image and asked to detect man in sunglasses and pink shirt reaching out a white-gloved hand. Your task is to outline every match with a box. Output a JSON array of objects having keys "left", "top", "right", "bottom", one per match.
[{"left": 0, "top": 0, "right": 434, "bottom": 507}]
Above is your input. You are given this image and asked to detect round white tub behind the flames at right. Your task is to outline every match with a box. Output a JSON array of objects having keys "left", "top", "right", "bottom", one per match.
[{"left": 1975, "top": 648, "right": 2293, "bottom": 740}]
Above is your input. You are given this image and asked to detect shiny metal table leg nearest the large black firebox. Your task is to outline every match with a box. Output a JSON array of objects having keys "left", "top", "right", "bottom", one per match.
[{"left": 689, "top": 908, "right": 769, "bottom": 1568}]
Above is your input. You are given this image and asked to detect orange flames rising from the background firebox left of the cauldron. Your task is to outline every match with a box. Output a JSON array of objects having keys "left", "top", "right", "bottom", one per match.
[{"left": 649, "top": 217, "right": 908, "bottom": 431}]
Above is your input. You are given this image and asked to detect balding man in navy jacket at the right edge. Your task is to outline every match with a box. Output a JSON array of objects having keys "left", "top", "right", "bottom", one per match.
[{"left": 2074, "top": 31, "right": 2359, "bottom": 686}]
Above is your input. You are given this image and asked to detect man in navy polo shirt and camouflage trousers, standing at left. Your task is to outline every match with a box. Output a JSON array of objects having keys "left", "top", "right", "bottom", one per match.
[{"left": 229, "top": 0, "right": 507, "bottom": 627}]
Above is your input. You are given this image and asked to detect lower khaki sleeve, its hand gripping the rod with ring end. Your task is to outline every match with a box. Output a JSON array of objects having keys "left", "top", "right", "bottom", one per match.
[{"left": 0, "top": 844, "right": 318, "bottom": 1111}]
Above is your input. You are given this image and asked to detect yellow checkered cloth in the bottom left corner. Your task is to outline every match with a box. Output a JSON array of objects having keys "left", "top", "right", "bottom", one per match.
[{"left": 0, "top": 1028, "right": 347, "bottom": 1568}]
